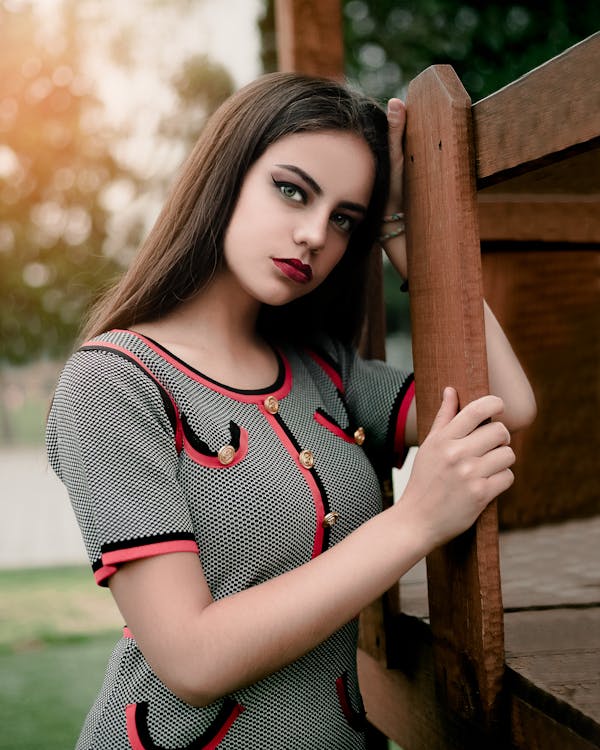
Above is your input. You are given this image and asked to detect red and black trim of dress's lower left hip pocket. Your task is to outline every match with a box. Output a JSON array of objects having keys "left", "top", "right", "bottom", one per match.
[{"left": 125, "top": 698, "right": 244, "bottom": 750}]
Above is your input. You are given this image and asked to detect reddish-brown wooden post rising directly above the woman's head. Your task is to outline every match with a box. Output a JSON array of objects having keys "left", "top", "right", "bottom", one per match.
[{"left": 275, "top": 0, "right": 344, "bottom": 80}]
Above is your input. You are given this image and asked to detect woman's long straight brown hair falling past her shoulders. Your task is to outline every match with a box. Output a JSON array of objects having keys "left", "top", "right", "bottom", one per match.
[{"left": 83, "top": 73, "right": 389, "bottom": 348}]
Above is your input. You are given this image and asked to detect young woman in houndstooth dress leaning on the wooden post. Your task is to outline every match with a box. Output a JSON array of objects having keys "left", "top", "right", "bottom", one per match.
[{"left": 48, "top": 74, "right": 535, "bottom": 750}]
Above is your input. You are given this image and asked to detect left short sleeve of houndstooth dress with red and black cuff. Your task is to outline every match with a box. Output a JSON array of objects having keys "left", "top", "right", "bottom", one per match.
[{"left": 46, "top": 350, "right": 198, "bottom": 585}]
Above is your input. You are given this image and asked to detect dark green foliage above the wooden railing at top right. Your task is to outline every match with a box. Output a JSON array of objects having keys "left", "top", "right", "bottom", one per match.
[{"left": 343, "top": 0, "right": 600, "bottom": 100}]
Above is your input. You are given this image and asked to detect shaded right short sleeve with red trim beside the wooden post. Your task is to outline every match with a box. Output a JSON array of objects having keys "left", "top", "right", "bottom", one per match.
[{"left": 310, "top": 341, "right": 415, "bottom": 468}]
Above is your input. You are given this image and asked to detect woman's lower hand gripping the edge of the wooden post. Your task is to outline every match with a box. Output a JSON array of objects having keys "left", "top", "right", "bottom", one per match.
[{"left": 398, "top": 388, "right": 515, "bottom": 549}]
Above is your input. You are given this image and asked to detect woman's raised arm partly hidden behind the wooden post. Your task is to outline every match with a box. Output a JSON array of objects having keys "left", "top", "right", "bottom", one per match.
[{"left": 382, "top": 99, "right": 536, "bottom": 445}]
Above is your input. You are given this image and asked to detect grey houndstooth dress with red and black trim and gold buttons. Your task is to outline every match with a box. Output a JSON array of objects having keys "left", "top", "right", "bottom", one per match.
[{"left": 47, "top": 331, "right": 414, "bottom": 750}]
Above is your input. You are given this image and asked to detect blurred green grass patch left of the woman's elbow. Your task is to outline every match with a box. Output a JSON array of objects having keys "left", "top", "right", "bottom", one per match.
[{"left": 0, "top": 567, "right": 122, "bottom": 750}]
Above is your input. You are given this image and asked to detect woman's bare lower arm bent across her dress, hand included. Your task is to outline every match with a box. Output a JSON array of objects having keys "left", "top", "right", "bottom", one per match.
[{"left": 110, "top": 388, "right": 514, "bottom": 705}]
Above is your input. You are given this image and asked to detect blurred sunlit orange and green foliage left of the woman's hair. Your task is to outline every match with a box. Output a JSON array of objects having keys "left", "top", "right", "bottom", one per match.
[{"left": 0, "top": 0, "right": 234, "bottom": 366}]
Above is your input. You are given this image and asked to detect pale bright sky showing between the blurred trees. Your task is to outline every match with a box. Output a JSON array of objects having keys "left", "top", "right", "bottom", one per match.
[{"left": 25, "top": 0, "right": 264, "bottom": 253}]
